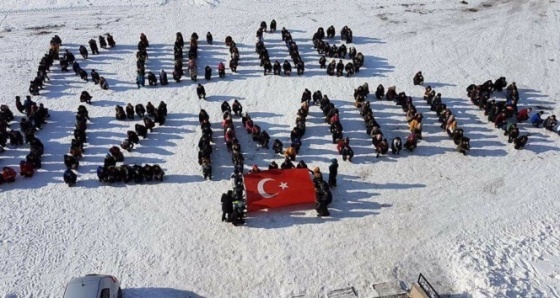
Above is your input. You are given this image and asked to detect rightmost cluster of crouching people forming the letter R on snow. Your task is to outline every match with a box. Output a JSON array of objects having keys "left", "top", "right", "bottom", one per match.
[{"left": 466, "top": 77, "right": 528, "bottom": 150}]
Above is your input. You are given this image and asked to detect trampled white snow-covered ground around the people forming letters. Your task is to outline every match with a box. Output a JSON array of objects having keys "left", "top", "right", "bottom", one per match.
[{"left": 0, "top": 0, "right": 560, "bottom": 298}]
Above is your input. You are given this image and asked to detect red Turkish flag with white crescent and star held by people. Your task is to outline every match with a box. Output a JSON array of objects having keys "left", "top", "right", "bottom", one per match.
[{"left": 243, "top": 169, "right": 315, "bottom": 212}]
